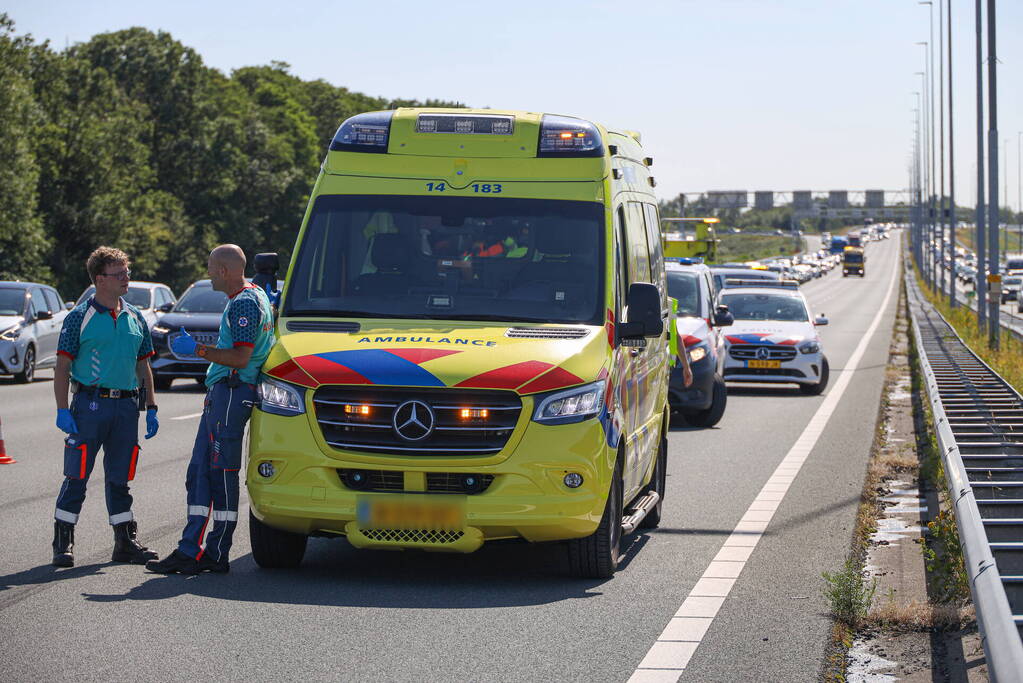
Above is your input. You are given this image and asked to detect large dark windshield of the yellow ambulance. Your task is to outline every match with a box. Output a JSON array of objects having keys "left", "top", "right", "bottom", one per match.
[{"left": 283, "top": 193, "right": 605, "bottom": 324}]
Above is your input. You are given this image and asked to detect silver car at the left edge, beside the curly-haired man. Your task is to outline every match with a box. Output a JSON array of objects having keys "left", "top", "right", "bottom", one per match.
[{"left": 0, "top": 280, "right": 72, "bottom": 383}]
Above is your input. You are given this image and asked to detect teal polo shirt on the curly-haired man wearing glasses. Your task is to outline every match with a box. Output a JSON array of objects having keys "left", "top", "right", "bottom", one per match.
[{"left": 57, "top": 297, "right": 153, "bottom": 390}]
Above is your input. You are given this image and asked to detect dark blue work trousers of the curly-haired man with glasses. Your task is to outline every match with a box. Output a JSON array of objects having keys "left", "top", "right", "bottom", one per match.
[{"left": 53, "top": 392, "right": 139, "bottom": 525}]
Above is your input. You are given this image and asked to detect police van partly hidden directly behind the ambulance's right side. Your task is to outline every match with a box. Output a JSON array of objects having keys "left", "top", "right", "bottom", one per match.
[{"left": 665, "top": 259, "right": 731, "bottom": 427}]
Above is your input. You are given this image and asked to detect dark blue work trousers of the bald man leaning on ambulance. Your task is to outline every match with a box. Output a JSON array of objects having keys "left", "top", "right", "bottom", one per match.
[{"left": 178, "top": 380, "right": 257, "bottom": 561}]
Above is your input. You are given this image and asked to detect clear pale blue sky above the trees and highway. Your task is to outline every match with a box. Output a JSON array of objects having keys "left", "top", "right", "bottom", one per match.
[{"left": 4, "top": 0, "right": 1023, "bottom": 207}]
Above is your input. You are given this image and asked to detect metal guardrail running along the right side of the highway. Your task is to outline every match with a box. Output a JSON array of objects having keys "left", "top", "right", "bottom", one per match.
[{"left": 905, "top": 268, "right": 1023, "bottom": 683}]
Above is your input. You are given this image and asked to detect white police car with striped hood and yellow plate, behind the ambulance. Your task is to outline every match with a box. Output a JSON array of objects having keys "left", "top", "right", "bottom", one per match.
[{"left": 717, "top": 280, "right": 830, "bottom": 395}]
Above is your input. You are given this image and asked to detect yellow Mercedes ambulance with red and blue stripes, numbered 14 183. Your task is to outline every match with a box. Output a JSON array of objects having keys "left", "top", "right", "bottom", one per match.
[{"left": 247, "top": 108, "right": 670, "bottom": 578}]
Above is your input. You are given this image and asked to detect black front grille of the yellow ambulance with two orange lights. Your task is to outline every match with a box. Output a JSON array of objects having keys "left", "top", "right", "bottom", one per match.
[{"left": 313, "top": 385, "right": 522, "bottom": 457}]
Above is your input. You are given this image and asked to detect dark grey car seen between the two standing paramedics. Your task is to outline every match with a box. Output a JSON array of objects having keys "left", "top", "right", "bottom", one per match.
[{"left": 148, "top": 278, "right": 283, "bottom": 391}]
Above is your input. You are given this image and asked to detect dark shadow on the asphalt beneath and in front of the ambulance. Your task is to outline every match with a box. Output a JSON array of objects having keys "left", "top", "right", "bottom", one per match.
[{"left": 75, "top": 534, "right": 650, "bottom": 609}]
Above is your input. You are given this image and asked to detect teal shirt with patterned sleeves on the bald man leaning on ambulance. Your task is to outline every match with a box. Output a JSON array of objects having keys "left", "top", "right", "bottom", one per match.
[{"left": 206, "top": 283, "right": 273, "bottom": 386}]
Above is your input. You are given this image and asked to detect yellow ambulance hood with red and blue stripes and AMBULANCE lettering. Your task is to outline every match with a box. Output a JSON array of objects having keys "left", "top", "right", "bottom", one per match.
[{"left": 263, "top": 319, "right": 608, "bottom": 395}]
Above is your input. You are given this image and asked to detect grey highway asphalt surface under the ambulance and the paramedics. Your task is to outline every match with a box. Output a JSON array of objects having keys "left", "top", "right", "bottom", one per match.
[{"left": 0, "top": 232, "right": 899, "bottom": 681}]
